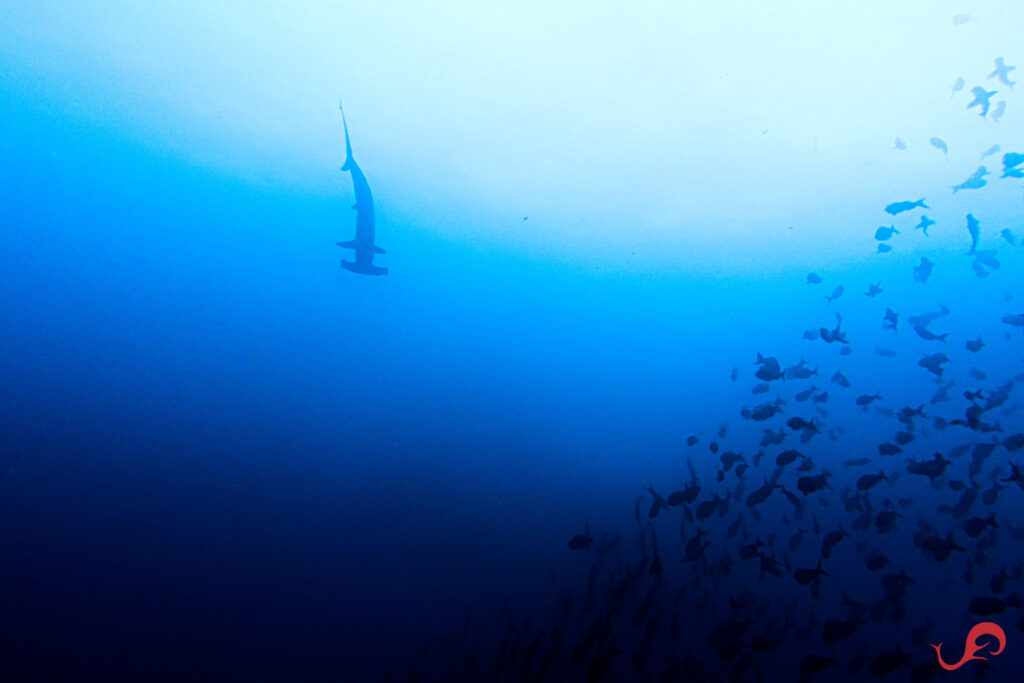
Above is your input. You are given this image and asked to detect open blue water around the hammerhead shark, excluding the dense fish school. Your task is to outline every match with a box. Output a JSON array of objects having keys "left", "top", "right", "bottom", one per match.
[{"left": 0, "top": 1, "right": 1024, "bottom": 680}]
